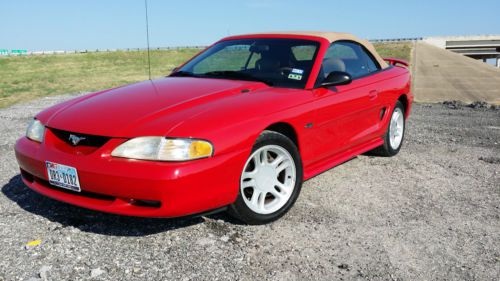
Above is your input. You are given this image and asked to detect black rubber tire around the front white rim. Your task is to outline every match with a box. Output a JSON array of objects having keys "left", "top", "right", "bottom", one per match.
[{"left": 228, "top": 131, "right": 303, "bottom": 225}]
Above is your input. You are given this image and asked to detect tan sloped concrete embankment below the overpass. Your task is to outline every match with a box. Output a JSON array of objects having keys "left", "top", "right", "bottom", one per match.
[{"left": 413, "top": 42, "right": 500, "bottom": 104}]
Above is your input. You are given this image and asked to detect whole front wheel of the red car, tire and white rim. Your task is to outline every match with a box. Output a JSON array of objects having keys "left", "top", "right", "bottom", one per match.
[{"left": 229, "top": 131, "right": 302, "bottom": 224}]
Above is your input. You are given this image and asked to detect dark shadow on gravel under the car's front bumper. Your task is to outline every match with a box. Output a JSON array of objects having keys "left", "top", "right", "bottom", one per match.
[{"left": 2, "top": 175, "right": 238, "bottom": 236}]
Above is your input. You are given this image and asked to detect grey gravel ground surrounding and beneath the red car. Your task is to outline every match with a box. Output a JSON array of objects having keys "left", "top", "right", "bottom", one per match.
[{"left": 0, "top": 96, "right": 500, "bottom": 280}]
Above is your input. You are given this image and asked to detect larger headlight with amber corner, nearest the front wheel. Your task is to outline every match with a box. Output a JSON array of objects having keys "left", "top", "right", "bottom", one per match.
[{"left": 111, "top": 137, "right": 213, "bottom": 161}]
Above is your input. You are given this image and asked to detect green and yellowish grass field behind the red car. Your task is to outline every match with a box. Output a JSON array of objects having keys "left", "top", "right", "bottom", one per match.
[{"left": 0, "top": 43, "right": 411, "bottom": 108}]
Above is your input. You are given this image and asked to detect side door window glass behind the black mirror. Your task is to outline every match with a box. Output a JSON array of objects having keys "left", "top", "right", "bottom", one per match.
[{"left": 320, "top": 41, "right": 377, "bottom": 79}]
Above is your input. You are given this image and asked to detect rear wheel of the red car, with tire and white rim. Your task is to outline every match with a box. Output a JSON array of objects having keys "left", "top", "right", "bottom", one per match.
[{"left": 373, "top": 101, "right": 406, "bottom": 156}]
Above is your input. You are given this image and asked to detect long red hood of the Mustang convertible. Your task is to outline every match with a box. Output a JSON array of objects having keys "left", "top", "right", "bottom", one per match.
[{"left": 43, "top": 77, "right": 269, "bottom": 137}]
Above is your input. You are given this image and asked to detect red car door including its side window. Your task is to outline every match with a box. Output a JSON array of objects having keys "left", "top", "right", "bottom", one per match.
[{"left": 313, "top": 41, "right": 380, "bottom": 160}]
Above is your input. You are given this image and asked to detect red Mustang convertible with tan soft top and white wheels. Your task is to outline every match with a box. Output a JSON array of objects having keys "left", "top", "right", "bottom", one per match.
[{"left": 15, "top": 32, "right": 413, "bottom": 224}]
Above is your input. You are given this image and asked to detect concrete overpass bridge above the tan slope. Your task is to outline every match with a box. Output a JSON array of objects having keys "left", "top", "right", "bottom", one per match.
[{"left": 423, "top": 35, "right": 500, "bottom": 68}]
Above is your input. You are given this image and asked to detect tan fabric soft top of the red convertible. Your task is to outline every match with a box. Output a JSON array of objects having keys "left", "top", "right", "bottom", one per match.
[{"left": 240, "top": 31, "right": 389, "bottom": 68}]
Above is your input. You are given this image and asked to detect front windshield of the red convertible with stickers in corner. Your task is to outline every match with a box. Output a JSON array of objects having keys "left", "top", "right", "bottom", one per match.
[{"left": 170, "top": 38, "right": 319, "bottom": 88}]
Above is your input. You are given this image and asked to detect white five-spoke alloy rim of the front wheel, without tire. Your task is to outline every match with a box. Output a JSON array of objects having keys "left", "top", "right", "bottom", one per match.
[{"left": 240, "top": 145, "right": 297, "bottom": 215}]
